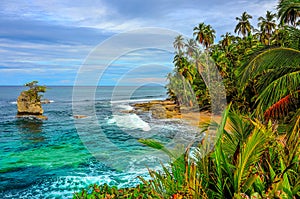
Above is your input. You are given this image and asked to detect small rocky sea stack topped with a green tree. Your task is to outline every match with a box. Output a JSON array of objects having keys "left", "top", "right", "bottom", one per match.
[{"left": 17, "top": 81, "right": 48, "bottom": 120}]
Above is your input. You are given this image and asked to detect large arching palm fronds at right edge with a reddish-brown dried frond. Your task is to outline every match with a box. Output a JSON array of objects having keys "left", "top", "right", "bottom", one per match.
[{"left": 241, "top": 48, "right": 300, "bottom": 120}]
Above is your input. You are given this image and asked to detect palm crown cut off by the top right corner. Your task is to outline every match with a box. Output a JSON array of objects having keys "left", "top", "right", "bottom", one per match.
[{"left": 277, "top": 0, "right": 300, "bottom": 27}]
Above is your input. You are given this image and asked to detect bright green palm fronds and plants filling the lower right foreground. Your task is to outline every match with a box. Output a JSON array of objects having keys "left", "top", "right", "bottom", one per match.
[{"left": 139, "top": 106, "right": 300, "bottom": 199}]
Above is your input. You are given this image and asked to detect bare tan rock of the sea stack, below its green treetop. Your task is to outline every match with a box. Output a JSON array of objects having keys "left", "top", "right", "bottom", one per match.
[{"left": 16, "top": 91, "right": 48, "bottom": 120}]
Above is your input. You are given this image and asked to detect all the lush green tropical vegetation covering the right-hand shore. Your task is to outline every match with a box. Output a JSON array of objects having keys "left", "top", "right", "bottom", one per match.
[{"left": 74, "top": 0, "right": 300, "bottom": 199}]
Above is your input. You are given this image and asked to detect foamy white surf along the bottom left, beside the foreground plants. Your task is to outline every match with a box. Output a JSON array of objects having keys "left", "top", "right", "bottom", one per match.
[{"left": 4, "top": 172, "right": 149, "bottom": 198}]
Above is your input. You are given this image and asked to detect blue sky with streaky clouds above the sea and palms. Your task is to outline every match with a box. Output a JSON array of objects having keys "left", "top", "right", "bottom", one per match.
[{"left": 0, "top": 0, "right": 277, "bottom": 85}]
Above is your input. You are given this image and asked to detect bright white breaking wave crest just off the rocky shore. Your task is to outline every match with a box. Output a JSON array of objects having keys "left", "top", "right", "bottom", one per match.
[{"left": 107, "top": 114, "right": 151, "bottom": 131}]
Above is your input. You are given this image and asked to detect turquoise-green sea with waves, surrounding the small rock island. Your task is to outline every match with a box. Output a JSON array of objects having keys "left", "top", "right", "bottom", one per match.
[{"left": 0, "top": 86, "right": 199, "bottom": 198}]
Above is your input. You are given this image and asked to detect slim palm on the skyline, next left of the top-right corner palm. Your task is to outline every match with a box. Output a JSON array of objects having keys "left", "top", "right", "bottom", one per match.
[{"left": 258, "top": 11, "right": 276, "bottom": 45}]
